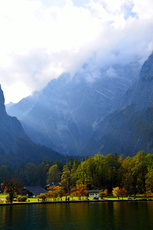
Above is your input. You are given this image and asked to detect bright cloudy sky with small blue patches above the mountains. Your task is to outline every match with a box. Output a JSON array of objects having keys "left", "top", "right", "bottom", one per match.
[{"left": 0, "top": 0, "right": 153, "bottom": 103}]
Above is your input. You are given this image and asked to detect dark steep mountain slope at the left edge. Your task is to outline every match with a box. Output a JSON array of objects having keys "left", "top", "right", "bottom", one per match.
[{"left": 0, "top": 86, "right": 63, "bottom": 164}]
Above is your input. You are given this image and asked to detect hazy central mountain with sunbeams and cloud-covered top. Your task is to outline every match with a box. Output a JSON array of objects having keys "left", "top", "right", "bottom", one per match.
[{"left": 7, "top": 62, "right": 140, "bottom": 155}]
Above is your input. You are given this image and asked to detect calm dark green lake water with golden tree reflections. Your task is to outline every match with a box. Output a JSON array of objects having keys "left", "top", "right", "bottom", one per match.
[{"left": 0, "top": 201, "right": 153, "bottom": 230}]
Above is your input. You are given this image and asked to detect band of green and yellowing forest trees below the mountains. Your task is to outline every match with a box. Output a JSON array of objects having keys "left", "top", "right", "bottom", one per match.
[{"left": 0, "top": 151, "right": 153, "bottom": 194}]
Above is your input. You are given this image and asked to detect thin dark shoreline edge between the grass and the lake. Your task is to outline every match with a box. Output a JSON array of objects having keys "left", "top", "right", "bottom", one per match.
[{"left": 0, "top": 199, "right": 149, "bottom": 206}]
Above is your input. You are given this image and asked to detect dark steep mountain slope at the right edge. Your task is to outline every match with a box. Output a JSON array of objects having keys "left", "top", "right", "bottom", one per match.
[{"left": 84, "top": 53, "right": 153, "bottom": 155}]
